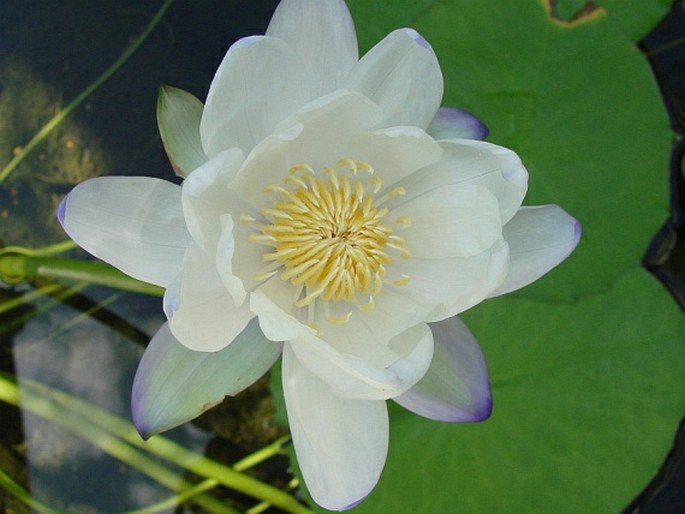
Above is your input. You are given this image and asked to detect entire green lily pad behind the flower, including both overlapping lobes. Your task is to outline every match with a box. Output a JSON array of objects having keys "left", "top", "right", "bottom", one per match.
[{"left": 284, "top": 0, "right": 685, "bottom": 514}]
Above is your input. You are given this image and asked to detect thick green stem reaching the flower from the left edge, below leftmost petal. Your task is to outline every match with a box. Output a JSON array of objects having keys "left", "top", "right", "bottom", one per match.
[{"left": 0, "top": 248, "right": 164, "bottom": 296}]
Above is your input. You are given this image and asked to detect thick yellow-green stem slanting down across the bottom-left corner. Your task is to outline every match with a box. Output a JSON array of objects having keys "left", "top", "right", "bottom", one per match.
[{"left": 0, "top": 372, "right": 312, "bottom": 514}]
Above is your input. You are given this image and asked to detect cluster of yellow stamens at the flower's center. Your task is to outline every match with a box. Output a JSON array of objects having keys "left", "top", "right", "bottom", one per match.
[{"left": 241, "top": 159, "right": 410, "bottom": 322}]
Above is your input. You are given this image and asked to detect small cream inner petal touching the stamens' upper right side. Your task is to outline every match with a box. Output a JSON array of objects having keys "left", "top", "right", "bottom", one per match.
[{"left": 350, "top": 127, "right": 442, "bottom": 185}]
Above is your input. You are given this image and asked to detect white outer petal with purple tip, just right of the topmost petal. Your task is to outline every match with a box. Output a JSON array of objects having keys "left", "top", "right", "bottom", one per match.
[{"left": 344, "top": 29, "right": 443, "bottom": 129}]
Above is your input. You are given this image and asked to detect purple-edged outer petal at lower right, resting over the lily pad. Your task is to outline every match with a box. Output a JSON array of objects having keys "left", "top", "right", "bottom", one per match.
[{"left": 393, "top": 316, "right": 492, "bottom": 422}]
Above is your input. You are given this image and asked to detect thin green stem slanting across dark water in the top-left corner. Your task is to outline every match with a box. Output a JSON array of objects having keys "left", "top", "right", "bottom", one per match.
[{"left": 0, "top": 0, "right": 173, "bottom": 183}]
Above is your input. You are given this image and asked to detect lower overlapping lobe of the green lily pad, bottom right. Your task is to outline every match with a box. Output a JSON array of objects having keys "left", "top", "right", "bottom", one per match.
[{"left": 355, "top": 269, "right": 685, "bottom": 513}]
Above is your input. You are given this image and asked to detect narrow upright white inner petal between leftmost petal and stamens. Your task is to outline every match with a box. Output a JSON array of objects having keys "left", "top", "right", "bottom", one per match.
[{"left": 182, "top": 148, "right": 243, "bottom": 256}]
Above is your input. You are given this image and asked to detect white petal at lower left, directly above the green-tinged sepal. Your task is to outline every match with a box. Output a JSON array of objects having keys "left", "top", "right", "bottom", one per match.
[{"left": 165, "top": 244, "right": 253, "bottom": 352}]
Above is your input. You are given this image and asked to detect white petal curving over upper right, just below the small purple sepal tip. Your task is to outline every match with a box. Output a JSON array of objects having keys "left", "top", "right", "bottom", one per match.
[{"left": 402, "top": 139, "right": 528, "bottom": 223}]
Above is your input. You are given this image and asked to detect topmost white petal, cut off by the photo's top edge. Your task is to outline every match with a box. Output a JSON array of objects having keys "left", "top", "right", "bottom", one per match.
[{"left": 266, "top": 0, "right": 359, "bottom": 98}]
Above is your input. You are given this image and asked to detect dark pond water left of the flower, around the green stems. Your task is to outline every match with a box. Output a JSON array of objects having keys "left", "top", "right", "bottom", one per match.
[{"left": 0, "top": 0, "right": 292, "bottom": 513}]
